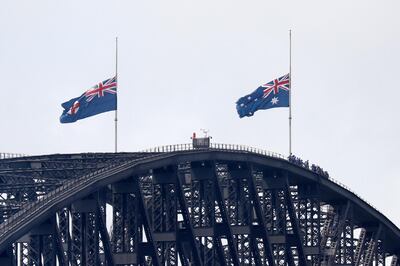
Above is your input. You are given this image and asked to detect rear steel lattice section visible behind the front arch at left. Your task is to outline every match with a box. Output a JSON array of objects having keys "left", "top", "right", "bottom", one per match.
[{"left": 0, "top": 153, "right": 155, "bottom": 227}]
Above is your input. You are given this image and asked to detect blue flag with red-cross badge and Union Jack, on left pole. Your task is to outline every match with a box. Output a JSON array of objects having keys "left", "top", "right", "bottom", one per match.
[{"left": 60, "top": 77, "right": 117, "bottom": 123}]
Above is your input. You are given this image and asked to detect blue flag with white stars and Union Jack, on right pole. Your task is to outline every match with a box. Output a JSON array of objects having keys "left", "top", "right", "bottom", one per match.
[{"left": 236, "top": 74, "right": 290, "bottom": 118}]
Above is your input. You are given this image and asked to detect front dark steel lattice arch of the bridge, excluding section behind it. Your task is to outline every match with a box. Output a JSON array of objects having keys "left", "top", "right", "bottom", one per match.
[{"left": 0, "top": 149, "right": 400, "bottom": 265}]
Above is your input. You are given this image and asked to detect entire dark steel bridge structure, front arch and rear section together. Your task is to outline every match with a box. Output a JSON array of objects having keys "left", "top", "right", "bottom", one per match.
[{"left": 0, "top": 144, "right": 400, "bottom": 265}]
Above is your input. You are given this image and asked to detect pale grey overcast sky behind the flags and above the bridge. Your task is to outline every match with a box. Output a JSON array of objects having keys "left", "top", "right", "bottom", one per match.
[{"left": 0, "top": 0, "right": 400, "bottom": 226}]
